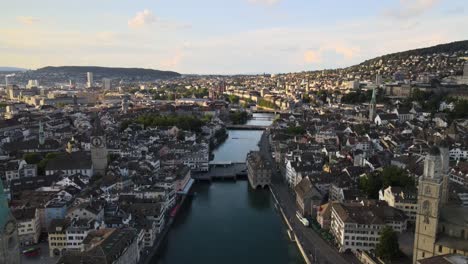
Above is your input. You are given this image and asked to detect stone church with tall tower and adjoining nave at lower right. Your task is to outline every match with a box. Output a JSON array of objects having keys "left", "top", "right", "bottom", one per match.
[{"left": 413, "top": 146, "right": 468, "bottom": 263}]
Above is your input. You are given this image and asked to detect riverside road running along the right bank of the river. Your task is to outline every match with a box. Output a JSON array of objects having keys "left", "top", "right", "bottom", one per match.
[{"left": 259, "top": 131, "right": 360, "bottom": 264}]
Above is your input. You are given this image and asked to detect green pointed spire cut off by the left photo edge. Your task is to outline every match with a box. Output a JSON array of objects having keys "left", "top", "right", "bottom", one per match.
[{"left": 0, "top": 180, "right": 20, "bottom": 264}]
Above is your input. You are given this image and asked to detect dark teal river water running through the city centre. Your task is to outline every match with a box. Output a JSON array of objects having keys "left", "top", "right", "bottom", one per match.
[{"left": 153, "top": 114, "right": 304, "bottom": 264}]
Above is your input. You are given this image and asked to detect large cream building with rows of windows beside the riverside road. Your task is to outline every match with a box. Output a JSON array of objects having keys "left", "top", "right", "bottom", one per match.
[{"left": 330, "top": 202, "right": 407, "bottom": 252}]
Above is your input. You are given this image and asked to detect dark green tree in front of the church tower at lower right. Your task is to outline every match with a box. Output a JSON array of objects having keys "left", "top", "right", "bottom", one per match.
[{"left": 375, "top": 226, "right": 400, "bottom": 261}]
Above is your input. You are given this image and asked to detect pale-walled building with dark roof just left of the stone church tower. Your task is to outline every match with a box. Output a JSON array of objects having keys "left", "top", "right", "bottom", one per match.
[{"left": 379, "top": 186, "right": 418, "bottom": 223}]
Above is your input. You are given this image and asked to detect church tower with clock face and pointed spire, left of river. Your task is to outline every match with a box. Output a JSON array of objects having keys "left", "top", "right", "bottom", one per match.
[{"left": 91, "top": 115, "right": 107, "bottom": 176}]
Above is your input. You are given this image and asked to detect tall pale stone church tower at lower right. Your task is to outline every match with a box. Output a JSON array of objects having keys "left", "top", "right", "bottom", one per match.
[{"left": 413, "top": 146, "right": 448, "bottom": 263}]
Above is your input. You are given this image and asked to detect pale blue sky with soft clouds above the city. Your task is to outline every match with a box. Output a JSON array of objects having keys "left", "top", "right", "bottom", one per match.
[{"left": 0, "top": 0, "right": 468, "bottom": 74}]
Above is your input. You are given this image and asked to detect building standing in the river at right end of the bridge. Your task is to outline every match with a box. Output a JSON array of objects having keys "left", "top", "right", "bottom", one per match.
[{"left": 247, "top": 151, "right": 272, "bottom": 189}]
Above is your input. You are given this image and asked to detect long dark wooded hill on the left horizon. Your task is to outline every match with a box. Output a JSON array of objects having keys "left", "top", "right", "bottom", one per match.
[{"left": 36, "top": 66, "right": 180, "bottom": 79}]
